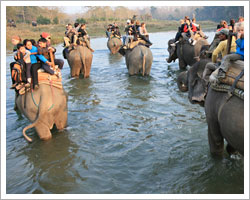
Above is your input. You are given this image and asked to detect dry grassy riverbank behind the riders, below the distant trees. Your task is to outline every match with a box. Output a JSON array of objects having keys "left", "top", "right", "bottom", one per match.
[{"left": 6, "top": 21, "right": 217, "bottom": 50}]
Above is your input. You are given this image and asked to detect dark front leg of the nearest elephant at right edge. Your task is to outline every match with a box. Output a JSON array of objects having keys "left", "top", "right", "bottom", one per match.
[{"left": 208, "top": 121, "right": 224, "bottom": 156}]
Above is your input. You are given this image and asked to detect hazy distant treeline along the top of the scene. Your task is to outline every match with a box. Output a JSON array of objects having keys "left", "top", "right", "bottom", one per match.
[{"left": 6, "top": 6, "right": 244, "bottom": 24}]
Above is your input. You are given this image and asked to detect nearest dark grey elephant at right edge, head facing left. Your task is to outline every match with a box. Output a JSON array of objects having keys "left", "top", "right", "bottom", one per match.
[{"left": 177, "top": 59, "right": 244, "bottom": 156}]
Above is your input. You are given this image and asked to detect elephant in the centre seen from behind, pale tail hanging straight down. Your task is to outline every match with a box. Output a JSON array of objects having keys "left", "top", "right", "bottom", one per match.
[{"left": 119, "top": 45, "right": 153, "bottom": 76}]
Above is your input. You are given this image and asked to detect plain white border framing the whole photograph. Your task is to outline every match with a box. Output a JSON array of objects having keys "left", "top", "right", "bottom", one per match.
[{"left": 1, "top": 1, "right": 249, "bottom": 199}]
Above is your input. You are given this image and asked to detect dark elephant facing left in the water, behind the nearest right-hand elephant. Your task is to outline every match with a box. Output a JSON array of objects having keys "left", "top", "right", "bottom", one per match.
[{"left": 167, "top": 38, "right": 209, "bottom": 70}]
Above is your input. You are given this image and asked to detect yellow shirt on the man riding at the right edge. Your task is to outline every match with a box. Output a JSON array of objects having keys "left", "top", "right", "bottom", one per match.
[{"left": 212, "top": 37, "right": 236, "bottom": 63}]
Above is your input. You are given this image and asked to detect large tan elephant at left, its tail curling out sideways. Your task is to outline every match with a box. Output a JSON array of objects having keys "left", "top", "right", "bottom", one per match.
[{"left": 15, "top": 84, "right": 68, "bottom": 142}]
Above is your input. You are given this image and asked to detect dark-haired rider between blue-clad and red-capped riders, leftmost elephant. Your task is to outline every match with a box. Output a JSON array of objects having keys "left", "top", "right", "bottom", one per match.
[{"left": 38, "top": 38, "right": 61, "bottom": 77}]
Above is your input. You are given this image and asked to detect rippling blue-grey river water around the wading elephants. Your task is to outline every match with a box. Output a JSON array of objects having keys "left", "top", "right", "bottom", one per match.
[{"left": 6, "top": 32, "right": 244, "bottom": 194}]
